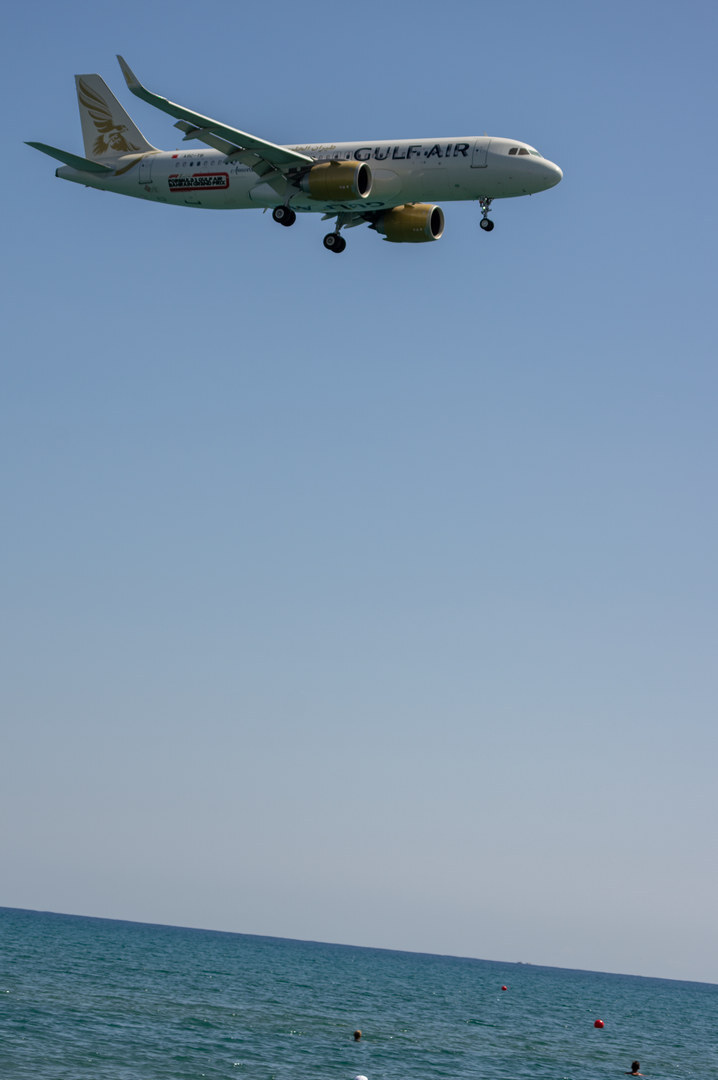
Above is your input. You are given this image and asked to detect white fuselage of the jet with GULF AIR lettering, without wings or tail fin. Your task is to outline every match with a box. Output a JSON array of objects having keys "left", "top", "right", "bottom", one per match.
[{"left": 57, "top": 135, "right": 563, "bottom": 214}]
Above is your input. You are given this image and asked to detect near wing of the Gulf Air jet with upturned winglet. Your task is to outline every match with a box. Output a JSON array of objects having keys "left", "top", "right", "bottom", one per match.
[{"left": 118, "top": 56, "right": 314, "bottom": 178}]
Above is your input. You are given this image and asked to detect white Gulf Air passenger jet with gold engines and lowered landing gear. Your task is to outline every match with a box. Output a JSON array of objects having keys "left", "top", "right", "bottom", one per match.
[{"left": 27, "top": 56, "right": 564, "bottom": 253}]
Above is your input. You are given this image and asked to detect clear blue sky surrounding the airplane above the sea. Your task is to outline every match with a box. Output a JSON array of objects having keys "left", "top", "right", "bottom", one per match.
[{"left": 0, "top": 0, "right": 718, "bottom": 982}]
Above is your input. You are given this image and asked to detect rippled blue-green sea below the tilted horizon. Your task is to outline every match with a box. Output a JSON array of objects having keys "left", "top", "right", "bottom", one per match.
[{"left": 0, "top": 908, "right": 718, "bottom": 1080}]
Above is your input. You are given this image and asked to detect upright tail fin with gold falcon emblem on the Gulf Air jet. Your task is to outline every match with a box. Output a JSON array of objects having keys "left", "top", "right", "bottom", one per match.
[{"left": 74, "top": 75, "right": 157, "bottom": 161}]
